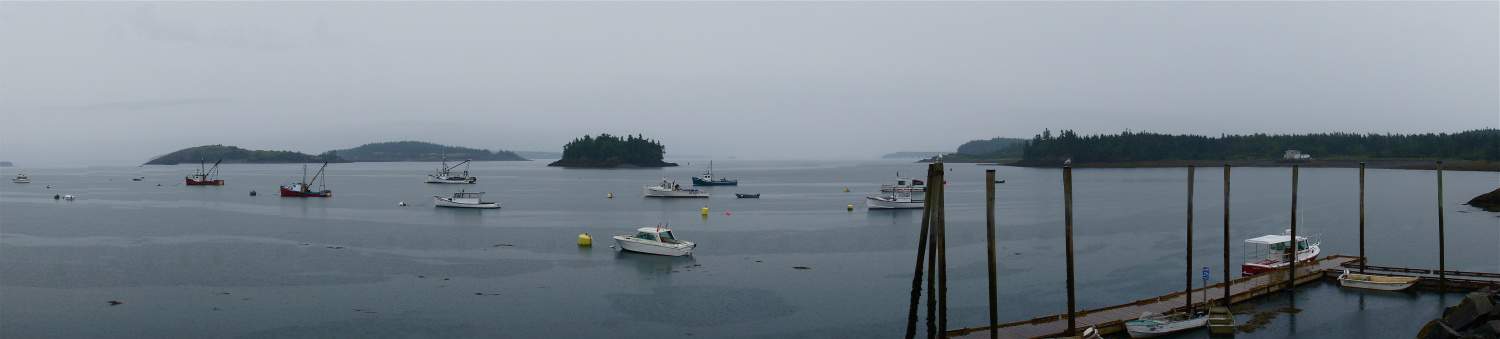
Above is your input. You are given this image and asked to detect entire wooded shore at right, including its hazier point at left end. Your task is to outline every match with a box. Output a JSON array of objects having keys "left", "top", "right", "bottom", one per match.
[{"left": 944, "top": 129, "right": 1500, "bottom": 171}]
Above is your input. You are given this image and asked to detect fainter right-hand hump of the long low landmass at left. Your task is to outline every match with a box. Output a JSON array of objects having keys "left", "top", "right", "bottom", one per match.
[{"left": 323, "top": 141, "right": 527, "bottom": 162}]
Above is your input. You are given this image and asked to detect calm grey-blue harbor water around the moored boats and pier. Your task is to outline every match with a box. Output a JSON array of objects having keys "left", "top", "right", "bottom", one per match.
[{"left": 0, "top": 161, "right": 1500, "bottom": 338}]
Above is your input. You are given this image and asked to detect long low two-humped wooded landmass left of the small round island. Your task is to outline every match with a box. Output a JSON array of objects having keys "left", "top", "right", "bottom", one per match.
[{"left": 146, "top": 141, "right": 527, "bottom": 165}]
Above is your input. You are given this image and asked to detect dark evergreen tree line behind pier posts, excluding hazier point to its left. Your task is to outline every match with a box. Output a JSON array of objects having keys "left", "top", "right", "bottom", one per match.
[{"left": 1022, "top": 129, "right": 1500, "bottom": 164}]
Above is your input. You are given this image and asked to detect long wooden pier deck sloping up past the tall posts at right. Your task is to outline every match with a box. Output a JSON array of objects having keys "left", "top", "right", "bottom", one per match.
[{"left": 948, "top": 255, "right": 1368, "bottom": 338}]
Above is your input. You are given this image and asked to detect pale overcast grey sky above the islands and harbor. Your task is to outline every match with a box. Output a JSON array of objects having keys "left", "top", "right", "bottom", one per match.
[{"left": 0, "top": 2, "right": 1500, "bottom": 167}]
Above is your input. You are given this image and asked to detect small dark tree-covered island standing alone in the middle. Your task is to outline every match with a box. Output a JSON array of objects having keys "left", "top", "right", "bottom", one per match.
[{"left": 548, "top": 134, "right": 677, "bottom": 168}]
